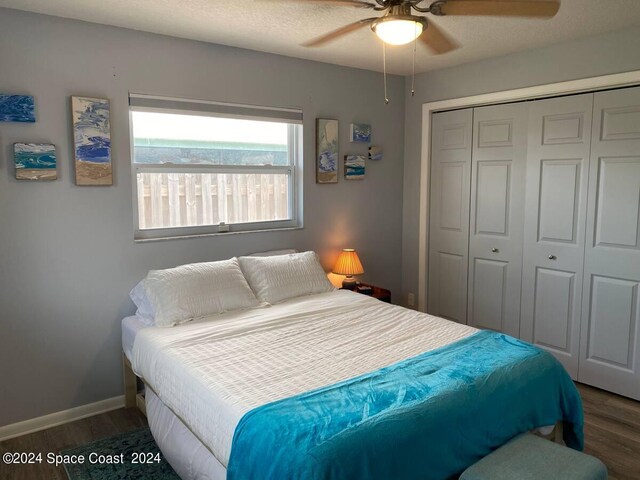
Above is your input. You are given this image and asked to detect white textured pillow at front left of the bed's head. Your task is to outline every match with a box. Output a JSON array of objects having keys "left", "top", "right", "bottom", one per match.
[{"left": 143, "top": 258, "right": 260, "bottom": 327}]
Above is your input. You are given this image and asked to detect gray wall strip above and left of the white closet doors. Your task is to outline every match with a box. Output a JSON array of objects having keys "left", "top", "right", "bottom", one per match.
[{"left": 397, "top": 28, "right": 640, "bottom": 305}]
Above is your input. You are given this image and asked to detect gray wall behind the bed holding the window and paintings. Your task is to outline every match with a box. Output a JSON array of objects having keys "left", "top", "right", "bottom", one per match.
[{"left": 0, "top": 9, "right": 405, "bottom": 426}]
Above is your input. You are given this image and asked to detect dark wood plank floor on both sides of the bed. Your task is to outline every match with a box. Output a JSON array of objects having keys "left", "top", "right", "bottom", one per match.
[{"left": 0, "top": 384, "right": 640, "bottom": 480}]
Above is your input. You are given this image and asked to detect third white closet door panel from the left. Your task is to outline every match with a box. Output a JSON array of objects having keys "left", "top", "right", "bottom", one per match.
[{"left": 520, "top": 94, "right": 593, "bottom": 380}]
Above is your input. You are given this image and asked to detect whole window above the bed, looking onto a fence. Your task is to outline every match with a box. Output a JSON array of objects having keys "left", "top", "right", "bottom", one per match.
[{"left": 129, "top": 94, "right": 302, "bottom": 240}]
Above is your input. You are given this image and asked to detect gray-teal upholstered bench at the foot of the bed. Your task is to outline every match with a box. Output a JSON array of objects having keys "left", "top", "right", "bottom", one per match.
[{"left": 460, "top": 433, "right": 608, "bottom": 480}]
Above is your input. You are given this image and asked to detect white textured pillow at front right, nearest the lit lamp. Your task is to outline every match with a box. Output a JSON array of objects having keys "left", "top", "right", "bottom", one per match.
[{"left": 239, "top": 252, "right": 335, "bottom": 304}]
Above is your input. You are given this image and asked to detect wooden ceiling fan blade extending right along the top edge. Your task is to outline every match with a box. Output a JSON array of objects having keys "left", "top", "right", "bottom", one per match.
[{"left": 440, "top": 0, "right": 560, "bottom": 18}]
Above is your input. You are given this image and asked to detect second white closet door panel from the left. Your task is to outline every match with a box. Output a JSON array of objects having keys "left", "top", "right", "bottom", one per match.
[{"left": 467, "top": 103, "right": 527, "bottom": 337}]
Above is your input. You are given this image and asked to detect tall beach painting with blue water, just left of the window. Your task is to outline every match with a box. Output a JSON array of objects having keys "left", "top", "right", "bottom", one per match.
[{"left": 71, "top": 97, "right": 113, "bottom": 185}]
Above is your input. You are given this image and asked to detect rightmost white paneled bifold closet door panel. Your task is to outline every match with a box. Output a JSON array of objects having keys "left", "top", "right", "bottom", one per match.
[{"left": 578, "top": 88, "right": 640, "bottom": 400}]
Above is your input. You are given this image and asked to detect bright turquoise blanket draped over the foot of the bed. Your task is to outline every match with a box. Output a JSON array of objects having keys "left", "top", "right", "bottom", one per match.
[{"left": 227, "top": 331, "right": 584, "bottom": 480}]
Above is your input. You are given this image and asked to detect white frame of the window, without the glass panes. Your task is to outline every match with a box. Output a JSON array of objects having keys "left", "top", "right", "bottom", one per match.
[{"left": 129, "top": 94, "right": 304, "bottom": 242}]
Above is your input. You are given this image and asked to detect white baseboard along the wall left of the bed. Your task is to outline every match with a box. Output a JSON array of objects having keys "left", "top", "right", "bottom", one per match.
[{"left": 0, "top": 395, "right": 124, "bottom": 442}]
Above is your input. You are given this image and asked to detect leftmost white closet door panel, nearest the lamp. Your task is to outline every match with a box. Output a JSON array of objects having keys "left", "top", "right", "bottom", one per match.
[{"left": 427, "top": 109, "right": 472, "bottom": 323}]
